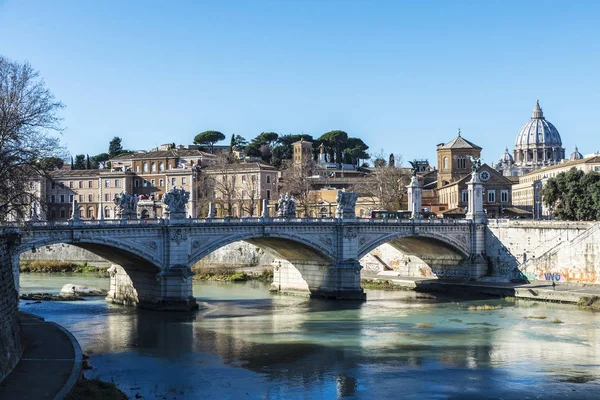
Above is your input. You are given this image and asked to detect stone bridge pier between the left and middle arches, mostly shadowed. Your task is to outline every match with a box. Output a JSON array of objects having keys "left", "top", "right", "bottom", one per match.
[{"left": 106, "top": 264, "right": 198, "bottom": 311}]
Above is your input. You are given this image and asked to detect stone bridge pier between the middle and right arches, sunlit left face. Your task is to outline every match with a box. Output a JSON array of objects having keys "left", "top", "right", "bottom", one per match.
[{"left": 271, "top": 260, "right": 366, "bottom": 300}]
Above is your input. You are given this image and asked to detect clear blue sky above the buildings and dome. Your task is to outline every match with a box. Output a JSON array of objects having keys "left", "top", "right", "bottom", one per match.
[{"left": 0, "top": 0, "right": 600, "bottom": 164}]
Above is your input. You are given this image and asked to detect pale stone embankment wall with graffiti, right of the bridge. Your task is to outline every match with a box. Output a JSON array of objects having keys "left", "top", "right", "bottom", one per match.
[{"left": 486, "top": 221, "right": 600, "bottom": 283}]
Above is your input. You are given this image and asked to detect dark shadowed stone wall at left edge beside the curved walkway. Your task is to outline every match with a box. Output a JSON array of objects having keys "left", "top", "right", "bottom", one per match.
[{"left": 0, "top": 233, "right": 23, "bottom": 381}]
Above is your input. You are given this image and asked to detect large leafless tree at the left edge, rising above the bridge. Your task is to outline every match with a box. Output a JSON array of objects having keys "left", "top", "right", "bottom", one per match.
[{"left": 0, "top": 56, "right": 65, "bottom": 220}]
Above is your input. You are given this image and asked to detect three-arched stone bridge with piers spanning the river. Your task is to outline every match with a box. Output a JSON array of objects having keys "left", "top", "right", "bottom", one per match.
[{"left": 3, "top": 218, "right": 487, "bottom": 309}]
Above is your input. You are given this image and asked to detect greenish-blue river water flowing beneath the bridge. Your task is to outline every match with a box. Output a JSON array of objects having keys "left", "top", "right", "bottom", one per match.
[{"left": 16, "top": 274, "right": 600, "bottom": 399}]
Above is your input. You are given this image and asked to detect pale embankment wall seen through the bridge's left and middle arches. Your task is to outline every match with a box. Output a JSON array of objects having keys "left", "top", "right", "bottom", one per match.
[{"left": 21, "top": 242, "right": 275, "bottom": 269}]
